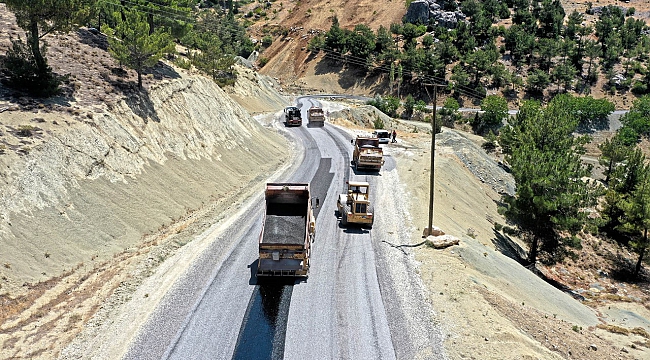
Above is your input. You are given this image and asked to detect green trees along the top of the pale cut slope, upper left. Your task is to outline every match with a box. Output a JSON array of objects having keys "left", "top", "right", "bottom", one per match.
[{"left": 2, "top": 0, "right": 260, "bottom": 97}]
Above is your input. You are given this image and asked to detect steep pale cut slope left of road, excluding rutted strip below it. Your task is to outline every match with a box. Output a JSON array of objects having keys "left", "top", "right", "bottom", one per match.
[{"left": 0, "top": 76, "right": 286, "bottom": 292}]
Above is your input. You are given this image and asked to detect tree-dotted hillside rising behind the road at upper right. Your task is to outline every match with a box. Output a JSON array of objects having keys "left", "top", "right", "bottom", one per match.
[{"left": 255, "top": 0, "right": 650, "bottom": 108}]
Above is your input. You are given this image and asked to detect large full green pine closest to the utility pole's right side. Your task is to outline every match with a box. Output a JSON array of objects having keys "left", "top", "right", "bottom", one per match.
[{"left": 500, "top": 101, "right": 593, "bottom": 263}]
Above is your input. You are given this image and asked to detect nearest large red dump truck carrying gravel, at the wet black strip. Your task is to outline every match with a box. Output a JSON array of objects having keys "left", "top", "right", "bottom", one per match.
[{"left": 257, "top": 183, "right": 316, "bottom": 277}]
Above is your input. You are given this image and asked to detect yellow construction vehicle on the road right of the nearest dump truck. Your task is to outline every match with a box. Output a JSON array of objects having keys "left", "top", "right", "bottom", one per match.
[{"left": 336, "top": 181, "right": 375, "bottom": 228}]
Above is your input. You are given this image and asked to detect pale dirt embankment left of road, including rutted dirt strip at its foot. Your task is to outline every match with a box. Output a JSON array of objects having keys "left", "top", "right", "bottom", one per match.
[{"left": 0, "top": 68, "right": 289, "bottom": 358}]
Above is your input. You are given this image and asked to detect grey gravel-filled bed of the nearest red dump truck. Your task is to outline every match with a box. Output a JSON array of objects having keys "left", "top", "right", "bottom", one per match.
[{"left": 261, "top": 203, "right": 307, "bottom": 245}]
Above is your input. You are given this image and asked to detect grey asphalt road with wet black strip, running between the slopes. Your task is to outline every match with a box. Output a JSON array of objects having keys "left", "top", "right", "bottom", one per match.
[{"left": 120, "top": 98, "right": 444, "bottom": 359}]
